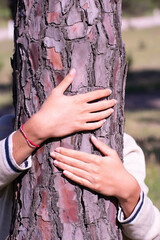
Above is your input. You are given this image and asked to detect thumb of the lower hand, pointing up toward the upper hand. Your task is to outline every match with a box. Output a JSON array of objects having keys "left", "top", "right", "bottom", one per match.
[{"left": 91, "top": 135, "right": 115, "bottom": 156}]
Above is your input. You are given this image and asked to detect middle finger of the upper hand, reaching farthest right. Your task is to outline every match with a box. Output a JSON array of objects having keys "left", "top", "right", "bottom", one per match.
[{"left": 88, "top": 99, "right": 117, "bottom": 112}]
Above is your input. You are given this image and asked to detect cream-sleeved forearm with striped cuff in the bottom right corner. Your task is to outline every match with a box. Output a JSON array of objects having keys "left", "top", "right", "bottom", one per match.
[{"left": 118, "top": 192, "right": 160, "bottom": 240}]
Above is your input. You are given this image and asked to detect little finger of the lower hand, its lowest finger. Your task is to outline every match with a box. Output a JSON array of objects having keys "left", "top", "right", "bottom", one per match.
[{"left": 63, "top": 170, "right": 93, "bottom": 190}]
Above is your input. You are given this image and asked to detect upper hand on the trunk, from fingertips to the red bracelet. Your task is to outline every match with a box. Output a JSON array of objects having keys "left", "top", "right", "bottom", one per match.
[{"left": 24, "top": 69, "right": 116, "bottom": 144}]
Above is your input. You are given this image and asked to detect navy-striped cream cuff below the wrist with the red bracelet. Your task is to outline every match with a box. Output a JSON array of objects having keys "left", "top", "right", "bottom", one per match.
[{"left": 4, "top": 133, "right": 32, "bottom": 173}]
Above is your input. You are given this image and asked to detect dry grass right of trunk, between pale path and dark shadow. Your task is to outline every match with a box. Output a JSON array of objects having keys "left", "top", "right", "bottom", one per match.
[{"left": 122, "top": 27, "right": 160, "bottom": 70}]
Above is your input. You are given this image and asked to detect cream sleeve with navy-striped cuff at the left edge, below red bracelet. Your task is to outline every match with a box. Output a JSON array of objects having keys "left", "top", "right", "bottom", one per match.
[{"left": 0, "top": 133, "right": 32, "bottom": 189}]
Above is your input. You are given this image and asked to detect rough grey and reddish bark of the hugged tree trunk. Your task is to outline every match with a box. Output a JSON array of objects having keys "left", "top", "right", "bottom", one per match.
[{"left": 11, "top": 0, "right": 126, "bottom": 240}]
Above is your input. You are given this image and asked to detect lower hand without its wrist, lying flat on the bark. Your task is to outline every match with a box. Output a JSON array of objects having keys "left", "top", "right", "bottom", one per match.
[{"left": 51, "top": 136, "right": 126, "bottom": 197}]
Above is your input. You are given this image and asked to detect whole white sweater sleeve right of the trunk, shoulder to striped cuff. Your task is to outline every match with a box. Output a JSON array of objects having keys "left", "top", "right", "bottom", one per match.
[{"left": 118, "top": 134, "right": 160, "bottom": 240}]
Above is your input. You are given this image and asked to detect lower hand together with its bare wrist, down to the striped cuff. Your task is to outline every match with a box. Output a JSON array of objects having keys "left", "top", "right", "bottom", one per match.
[{"left": 51, "top": 136, "right": 141, "bottom": 217}]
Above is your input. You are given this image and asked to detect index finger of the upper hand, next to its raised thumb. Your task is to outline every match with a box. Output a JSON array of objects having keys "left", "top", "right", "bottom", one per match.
[{"left": 79, "top": 89, "right": 112, "bottom": 102}]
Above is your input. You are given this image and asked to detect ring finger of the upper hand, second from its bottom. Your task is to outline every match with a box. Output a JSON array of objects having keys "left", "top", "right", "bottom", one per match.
[{"left": 86, "top": 108, "right": 114, "bottom": 122}]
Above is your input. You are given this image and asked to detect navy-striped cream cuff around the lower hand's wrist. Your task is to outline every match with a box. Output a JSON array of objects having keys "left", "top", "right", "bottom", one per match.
[{"left": 117, "top": 192, "right": 144, "bottom": 224}]
